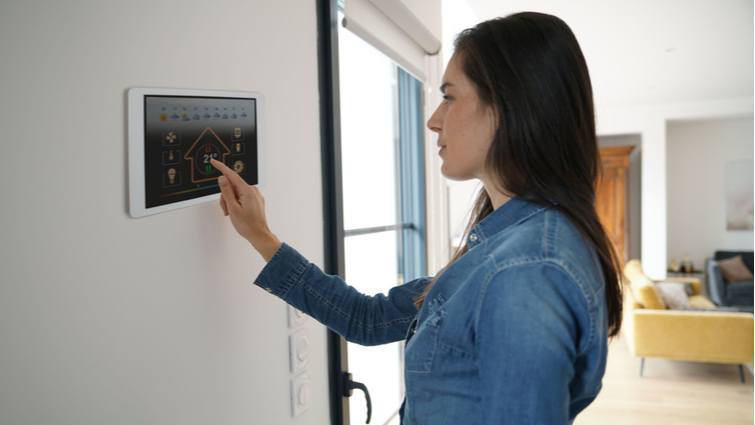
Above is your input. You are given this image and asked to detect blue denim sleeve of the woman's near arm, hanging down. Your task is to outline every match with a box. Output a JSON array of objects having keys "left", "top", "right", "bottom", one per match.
[{"left": 476, "top": 263, "right": 586, "bottom": 425}]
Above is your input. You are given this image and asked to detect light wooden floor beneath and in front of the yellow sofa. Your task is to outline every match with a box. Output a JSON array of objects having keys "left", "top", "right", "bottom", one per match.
[{"left": 574, "top": 332, "right": 753, "bottom": 425}]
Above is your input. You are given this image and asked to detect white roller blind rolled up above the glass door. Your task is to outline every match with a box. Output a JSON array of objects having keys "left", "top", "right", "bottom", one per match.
[{"left": 343, "top": 0, "right": 441, "bottom": 81}]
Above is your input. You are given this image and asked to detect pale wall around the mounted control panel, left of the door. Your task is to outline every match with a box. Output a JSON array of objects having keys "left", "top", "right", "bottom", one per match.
[{"left": 0, "top": 0, "right": 329, "bottom": 425}]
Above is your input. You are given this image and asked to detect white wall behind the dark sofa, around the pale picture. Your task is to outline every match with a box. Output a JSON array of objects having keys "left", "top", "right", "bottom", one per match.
[{"left": 666, "top": 116, "right": 753, "bottom": 268}]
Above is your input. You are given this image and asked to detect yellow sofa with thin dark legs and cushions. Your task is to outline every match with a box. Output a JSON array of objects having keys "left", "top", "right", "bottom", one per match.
[{"left": 623, "top": 260, "right": 753, "bottom": 382}]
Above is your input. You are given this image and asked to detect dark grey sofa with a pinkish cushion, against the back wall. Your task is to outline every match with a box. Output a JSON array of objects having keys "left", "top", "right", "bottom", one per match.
[{"left": 705, "top": 251, "right": 753, "bottom": 308}]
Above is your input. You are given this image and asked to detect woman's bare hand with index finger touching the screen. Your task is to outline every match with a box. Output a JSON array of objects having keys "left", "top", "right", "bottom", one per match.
[{"left": 210, "top": 159, "right": 281, "bottom": 261}]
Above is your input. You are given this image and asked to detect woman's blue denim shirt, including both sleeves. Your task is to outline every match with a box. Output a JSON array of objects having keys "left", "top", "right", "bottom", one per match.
[{"left": 255, "top": 197, "right": 608, "bottom": 425}]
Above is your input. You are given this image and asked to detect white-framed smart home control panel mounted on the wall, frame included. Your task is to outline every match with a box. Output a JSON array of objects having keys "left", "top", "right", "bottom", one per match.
[{"left": 128, "top": 88, "right": 262, "bottom": 217}]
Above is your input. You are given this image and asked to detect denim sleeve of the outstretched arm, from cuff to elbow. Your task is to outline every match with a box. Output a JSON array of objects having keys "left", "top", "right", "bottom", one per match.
[{"left": 254, "top": 242, "right": 429, "bottom": 345}]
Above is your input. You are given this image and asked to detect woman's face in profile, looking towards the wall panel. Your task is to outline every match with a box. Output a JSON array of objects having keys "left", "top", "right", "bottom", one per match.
[{"left": 427, "top": 54, "right": 496, "bottom": 180}]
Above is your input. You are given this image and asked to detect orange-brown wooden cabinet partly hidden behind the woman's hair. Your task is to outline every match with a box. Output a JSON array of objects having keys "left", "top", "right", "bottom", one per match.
[{"left": 595, "top": 146, "right": 634, "bottom": 267}]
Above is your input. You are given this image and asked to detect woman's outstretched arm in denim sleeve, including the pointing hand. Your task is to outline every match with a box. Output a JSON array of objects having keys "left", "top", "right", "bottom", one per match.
[{"left": 211, "top": 160, "right": 428, "bottom": 345}]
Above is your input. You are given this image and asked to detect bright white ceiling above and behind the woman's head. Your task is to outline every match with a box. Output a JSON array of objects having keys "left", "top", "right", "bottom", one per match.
[{"left": 467, "top": 0, "right": 753, "bottom": 109}]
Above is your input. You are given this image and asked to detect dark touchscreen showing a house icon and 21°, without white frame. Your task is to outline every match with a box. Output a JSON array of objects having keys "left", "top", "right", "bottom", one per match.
[{"left": 144, "top": 95, "right": 258, "bottom": 208}]
